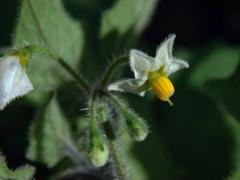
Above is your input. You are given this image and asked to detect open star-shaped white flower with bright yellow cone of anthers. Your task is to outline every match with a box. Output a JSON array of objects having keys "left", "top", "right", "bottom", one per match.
[{"left": 108, "top": 34, "right": 189, "bottom": 104}]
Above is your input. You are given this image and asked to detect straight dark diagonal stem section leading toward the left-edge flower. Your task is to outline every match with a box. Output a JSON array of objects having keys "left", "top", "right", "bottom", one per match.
[{"left": 57, "top": 57, "right": 91, "bottom": 95}]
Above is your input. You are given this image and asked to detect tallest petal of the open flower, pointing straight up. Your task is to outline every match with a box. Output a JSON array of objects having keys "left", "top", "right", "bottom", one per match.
[{"left": 155, "top": 34, "right": 176, "bottom": 67}]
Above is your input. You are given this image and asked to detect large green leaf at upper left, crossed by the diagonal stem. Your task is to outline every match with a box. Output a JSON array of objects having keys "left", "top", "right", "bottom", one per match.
[{"left": 13, "top": 0, "right": 83, "bottom": 98}]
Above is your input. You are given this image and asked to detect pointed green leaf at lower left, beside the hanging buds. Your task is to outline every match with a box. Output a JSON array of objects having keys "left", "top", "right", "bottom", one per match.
[{"left": 27, "top": 94, "right": 72, "bottom": 167}]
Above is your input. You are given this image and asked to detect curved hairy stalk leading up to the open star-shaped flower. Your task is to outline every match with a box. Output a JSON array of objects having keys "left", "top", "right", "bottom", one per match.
[{"left": 100, "top": 55, "right": 128, "bottom": 87}]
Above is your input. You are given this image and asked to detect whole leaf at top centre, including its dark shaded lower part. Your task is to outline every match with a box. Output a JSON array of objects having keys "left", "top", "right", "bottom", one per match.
[{"left": 100, "top": 0, "right": 158, "bottom": 52}]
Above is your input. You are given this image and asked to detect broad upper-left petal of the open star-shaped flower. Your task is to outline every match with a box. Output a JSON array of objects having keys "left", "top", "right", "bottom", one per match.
[{"left": 129, "top": 49, "right": 155, "bottom": 80}]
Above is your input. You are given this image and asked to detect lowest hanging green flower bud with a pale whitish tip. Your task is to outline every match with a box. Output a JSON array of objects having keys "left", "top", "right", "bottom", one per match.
[{"left": 88, "top": 120, "right": 109, "bottom": 167}]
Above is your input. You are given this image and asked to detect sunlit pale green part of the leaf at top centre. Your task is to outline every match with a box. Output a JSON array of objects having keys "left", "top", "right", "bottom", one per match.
[{"left": 101, "top": 0, "right": 157, "bottom": 36}]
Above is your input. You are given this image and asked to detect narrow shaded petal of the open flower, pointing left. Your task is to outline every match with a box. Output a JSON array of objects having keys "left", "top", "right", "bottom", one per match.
[{"left": 107, "top": 79, "right": 146, "bottom": 94}]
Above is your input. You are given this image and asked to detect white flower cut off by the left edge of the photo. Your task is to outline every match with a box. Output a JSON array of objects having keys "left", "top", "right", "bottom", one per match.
[{"left": 0, "top": 54, "right": 33, "bottom": 110}]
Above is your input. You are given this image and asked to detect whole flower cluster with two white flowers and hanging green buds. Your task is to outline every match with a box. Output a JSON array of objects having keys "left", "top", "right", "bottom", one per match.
[{"left": 0, "top": 35, "right": 189, "bottom": 170}]
